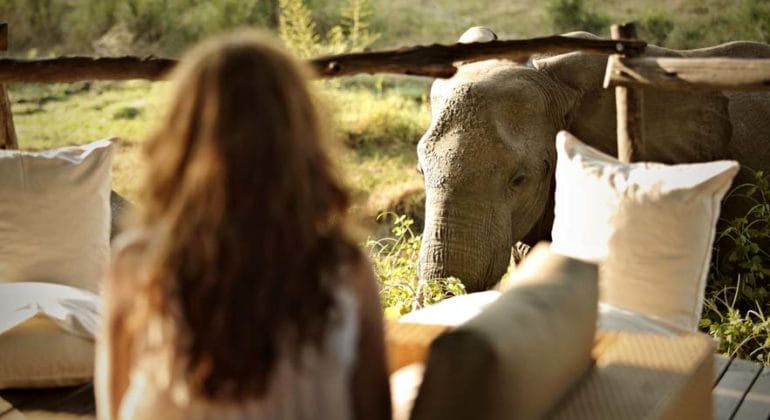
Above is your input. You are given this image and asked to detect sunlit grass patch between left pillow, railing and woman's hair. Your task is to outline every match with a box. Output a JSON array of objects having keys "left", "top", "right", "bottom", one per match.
[{"left": 10, "top": 81, "right": 166, "bottom": 200}]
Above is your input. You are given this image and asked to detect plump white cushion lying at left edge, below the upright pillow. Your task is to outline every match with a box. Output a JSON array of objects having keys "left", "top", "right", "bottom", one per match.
[{"left": 0, "top": 283, "right": 99, "bottom": 389}]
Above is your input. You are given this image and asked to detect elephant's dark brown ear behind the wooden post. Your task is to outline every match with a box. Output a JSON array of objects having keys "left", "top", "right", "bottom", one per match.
[{"left": 532, "top": 47, "right": 732, "bottom": 163}]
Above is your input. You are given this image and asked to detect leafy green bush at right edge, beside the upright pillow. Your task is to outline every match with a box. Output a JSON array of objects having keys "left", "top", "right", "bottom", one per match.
[{"left": 701, "top": 171, "right": 770, "bottom": 363}]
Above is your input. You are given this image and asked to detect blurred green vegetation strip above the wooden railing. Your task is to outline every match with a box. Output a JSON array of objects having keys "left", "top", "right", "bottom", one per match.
[{"left": 0, "top": 0, "right": 770, "bottom": 56}]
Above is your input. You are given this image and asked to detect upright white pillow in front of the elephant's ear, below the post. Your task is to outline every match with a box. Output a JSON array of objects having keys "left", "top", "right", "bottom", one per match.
[{"left": 552, "top": 131, "right": 739, "bottom": 331}]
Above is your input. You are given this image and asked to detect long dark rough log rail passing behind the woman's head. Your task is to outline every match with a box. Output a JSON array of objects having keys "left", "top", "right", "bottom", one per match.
[{"left": 0, "top": 36, "right": 646, "bottom": 83}]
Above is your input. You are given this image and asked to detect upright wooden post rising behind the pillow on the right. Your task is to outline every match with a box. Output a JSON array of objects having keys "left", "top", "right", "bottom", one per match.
[{"left": 610, "top": 23, "right": 644, "bottom": 162}]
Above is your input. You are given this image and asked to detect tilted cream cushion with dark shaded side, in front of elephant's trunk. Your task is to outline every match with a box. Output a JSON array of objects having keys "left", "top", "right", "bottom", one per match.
[{"left": 411, "top": 245, "right": 598, "bottom": 420}]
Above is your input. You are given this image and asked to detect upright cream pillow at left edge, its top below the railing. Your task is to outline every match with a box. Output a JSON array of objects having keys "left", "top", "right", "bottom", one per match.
[{"left": 0, "top": 140, "right": 112, "bottom": 291}]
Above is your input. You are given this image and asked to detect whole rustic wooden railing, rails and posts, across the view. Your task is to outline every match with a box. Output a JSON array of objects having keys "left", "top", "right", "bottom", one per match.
[{"left": 0, "top": 23, "right": 770, "bottom": 161}]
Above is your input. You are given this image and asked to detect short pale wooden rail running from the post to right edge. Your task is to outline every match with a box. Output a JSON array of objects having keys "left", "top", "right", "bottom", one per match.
[{"left": 604, "top": 56, "right": 770, "bottom": 90}]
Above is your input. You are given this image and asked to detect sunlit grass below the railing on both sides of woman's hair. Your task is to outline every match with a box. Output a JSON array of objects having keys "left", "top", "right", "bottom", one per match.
[{"left": 4, "top": 79, "right": 430, "bottom": 228}]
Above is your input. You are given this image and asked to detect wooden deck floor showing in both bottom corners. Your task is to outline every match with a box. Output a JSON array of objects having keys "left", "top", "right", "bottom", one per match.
[{"left": 0, "top": 356, "right": 770, "bottom": 420}]
